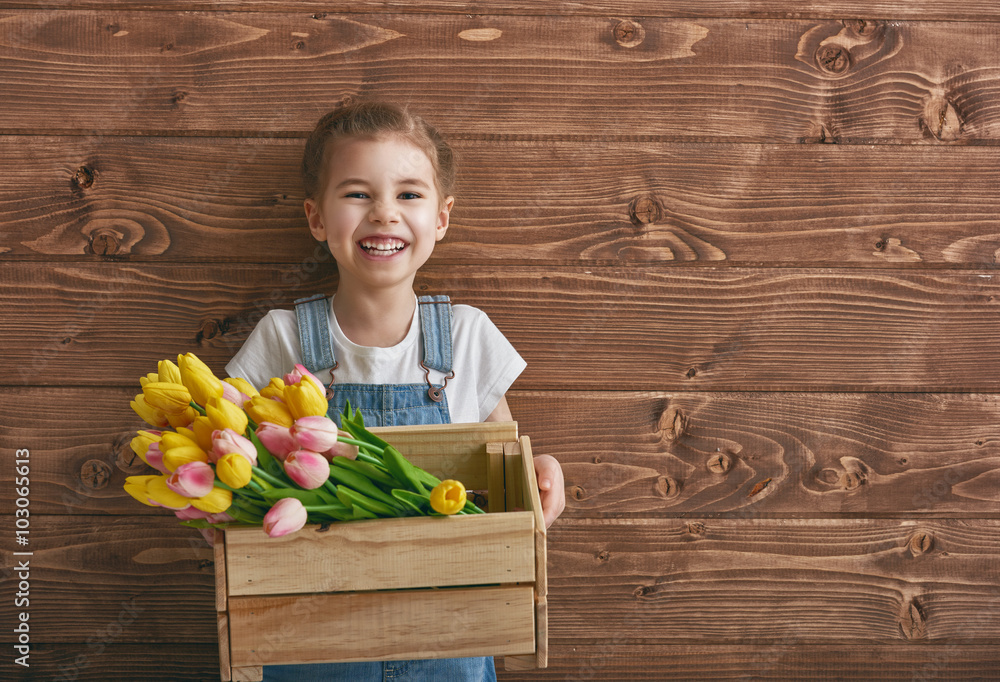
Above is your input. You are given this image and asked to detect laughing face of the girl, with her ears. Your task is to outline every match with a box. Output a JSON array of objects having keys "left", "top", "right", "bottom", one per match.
[{"left": 305, "top": 137, "right": 454, "bottom": 288}]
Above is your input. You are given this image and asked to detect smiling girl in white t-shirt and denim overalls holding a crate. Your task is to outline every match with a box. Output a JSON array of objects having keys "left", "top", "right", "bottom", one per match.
[{"left": 226, "top": 102, "right": 565, "bottom": 682}]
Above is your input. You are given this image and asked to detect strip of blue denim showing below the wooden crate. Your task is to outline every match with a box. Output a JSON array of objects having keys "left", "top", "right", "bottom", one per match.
[{"left": 264, "top": 656, "right": 497, "bottom": 682}]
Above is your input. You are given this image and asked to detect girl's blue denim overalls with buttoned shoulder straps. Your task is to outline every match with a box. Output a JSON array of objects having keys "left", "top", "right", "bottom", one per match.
[{"left": 264, "top": 296, "right": 496, "bottom": 682}]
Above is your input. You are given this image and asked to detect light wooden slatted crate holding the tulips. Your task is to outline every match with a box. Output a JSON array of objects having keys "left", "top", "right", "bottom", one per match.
[{"left": 215, "top": 422, "right": 547, "bottom": 680}]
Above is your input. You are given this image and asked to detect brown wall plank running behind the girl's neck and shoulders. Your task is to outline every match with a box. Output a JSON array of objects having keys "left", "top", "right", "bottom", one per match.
[{"left": 0, "top": 263, "right": 1000, "bottom": 392}]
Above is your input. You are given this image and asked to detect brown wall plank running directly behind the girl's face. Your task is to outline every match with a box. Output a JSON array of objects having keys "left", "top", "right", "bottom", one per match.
[{"left": 0, "top": 136, "right": 1000, "bottom": 269}]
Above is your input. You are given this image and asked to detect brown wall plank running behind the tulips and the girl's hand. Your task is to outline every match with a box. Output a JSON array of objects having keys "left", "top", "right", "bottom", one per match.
[{"left": 0, "top": 387, "right": 1000, "bottom": 523}]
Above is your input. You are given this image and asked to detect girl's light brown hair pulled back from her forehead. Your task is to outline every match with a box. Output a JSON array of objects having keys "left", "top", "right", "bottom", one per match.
[{"left": 302, "top": 102, "right": 455, "bottom": 203}]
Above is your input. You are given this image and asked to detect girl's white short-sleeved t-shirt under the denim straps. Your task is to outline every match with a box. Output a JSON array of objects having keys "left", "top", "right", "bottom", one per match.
[{"left": 226, "top": 294, "right": 526, "bottom": 424}]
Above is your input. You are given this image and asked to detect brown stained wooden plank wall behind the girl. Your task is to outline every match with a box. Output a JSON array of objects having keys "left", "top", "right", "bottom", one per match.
[{"left": 0, "top": 0, "right": 1000, "bottom": 681}]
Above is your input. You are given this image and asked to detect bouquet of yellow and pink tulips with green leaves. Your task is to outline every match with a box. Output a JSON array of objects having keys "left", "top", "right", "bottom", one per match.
[{"left": 125, "top": 353, "right": 483, "bottom": 538}]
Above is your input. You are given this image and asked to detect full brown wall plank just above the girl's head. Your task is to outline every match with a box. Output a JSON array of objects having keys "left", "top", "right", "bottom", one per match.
[{"left": 0, "top": 10, "right": 1000, "bottom": 144}]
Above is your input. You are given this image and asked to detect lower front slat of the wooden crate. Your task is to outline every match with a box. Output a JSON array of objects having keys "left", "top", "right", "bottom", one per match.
[{"left": 230, "top": 585, "right": 535, "bottom": 667}]
